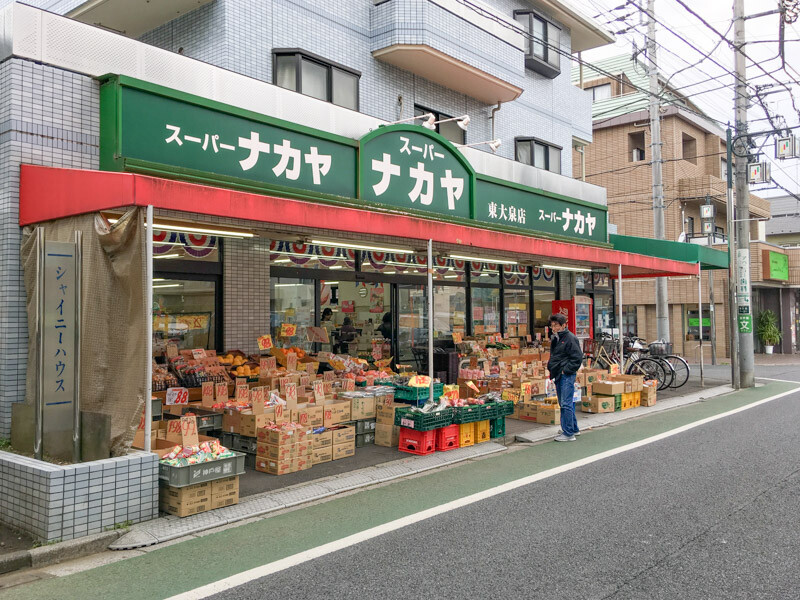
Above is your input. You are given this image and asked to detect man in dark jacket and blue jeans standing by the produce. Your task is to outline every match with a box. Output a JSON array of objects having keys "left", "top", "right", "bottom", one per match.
[{"left": 547, "top": 314, "right": 583, "bottom": 442}]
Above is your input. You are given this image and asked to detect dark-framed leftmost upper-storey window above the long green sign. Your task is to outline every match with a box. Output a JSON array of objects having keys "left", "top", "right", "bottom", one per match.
[{"left": 273, "top": 49, "right": 361, "bottom": 110}]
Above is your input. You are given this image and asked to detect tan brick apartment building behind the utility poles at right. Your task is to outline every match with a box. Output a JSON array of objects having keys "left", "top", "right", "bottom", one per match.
[{"left": 572, "top": 56, "right": 784, "bottom": 360}]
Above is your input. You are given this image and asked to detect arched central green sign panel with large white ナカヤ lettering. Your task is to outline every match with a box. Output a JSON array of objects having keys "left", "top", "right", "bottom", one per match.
[{"left": 359, "top": 125, "right": 475, "bottom": 219}]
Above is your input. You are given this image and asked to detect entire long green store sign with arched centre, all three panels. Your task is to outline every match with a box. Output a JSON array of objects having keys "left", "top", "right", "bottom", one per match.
[{"left": 100, "top": 75, "right": 608, "bottom": 244}]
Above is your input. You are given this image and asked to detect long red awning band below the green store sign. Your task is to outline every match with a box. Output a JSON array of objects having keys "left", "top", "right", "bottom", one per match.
[{"left": 19, "top": 165, "right": 698, "bottom": 278}]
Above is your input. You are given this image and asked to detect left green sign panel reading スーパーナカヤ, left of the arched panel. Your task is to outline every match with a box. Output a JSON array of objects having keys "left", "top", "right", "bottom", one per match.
[{"left": 100, "top": 76, "right": 356, "bottom": 198}]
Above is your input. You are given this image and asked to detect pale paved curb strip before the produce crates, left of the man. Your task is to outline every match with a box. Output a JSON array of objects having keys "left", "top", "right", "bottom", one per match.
[{"left": 109, "top": 442, "right": 506, "bottom": 550}]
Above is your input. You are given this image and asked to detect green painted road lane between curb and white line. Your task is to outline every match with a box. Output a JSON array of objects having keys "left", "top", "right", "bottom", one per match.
[{"left": 0, "top": 382, "right": 800, "bottom": 600}]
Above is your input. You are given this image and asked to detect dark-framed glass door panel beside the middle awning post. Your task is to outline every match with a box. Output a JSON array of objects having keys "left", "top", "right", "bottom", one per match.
[{"left": 395, "top": 283, "right": 428, "bottom": 372}]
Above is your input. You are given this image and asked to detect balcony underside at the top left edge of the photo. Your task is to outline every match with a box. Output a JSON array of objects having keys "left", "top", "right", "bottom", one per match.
[{"left": 67, "top": 0, "right": 213, "bottom": 38}]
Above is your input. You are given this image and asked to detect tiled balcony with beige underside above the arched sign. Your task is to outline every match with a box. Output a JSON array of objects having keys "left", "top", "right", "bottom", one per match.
[{"left": 370, "top": 0, "right": 525, "bottom": 104}]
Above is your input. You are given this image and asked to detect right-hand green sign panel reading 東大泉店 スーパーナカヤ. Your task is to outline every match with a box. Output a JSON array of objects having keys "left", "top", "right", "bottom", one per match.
[{"left": 475, "top": 176, "right": 608, "bottom": 243}]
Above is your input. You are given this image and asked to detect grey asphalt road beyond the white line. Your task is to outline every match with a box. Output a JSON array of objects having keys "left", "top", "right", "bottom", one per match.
[{"left": 209, "top": 367, "right": 800, "bottom": 600}]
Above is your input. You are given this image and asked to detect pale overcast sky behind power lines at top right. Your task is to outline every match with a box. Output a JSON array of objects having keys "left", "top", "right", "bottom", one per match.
[{"left": 565, "top": 0, "right": 800, "bottom": 196}]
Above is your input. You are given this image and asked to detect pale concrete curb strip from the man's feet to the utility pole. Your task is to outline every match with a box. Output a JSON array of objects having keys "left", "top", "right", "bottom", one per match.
[{"left": 508, "top": 385, "right": 734, "bottom": 443}]
